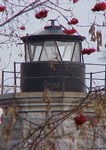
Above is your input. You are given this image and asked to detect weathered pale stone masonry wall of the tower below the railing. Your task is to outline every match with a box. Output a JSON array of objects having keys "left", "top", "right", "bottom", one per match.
[{"left": 0, "top": 90, "right": 105, "bottom": 150}]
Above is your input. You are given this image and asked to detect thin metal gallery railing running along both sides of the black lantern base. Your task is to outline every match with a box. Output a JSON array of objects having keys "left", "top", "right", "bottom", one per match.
[{"left": 1, "top": 62, "right": 106, "bottom": 94}]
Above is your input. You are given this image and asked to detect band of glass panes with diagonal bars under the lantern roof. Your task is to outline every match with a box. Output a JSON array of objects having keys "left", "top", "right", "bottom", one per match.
[{"left": 26, "top": 41, "right": 81, "bottom": 62}]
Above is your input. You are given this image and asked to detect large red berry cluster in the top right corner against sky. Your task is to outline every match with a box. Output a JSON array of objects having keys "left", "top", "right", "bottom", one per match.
[{"left": 91, "top": 2, "right": 106, "bottom": 11}]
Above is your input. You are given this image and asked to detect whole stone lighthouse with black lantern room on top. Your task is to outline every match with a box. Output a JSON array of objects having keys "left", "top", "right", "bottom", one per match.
[{"left": 0, "top": 20, "right": 105, "bottom": 150}]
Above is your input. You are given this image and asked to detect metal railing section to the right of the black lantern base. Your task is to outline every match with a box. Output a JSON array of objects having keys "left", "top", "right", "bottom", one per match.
[{"left": 85, "top": 63, "right": 106, "bottom": 91}]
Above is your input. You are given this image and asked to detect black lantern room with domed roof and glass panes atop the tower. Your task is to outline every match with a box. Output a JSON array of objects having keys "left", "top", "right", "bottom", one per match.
[{"left": 21, "top": 20, "right": 85, "bottom": 92}]
